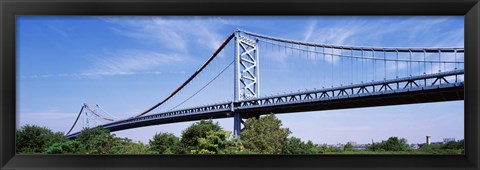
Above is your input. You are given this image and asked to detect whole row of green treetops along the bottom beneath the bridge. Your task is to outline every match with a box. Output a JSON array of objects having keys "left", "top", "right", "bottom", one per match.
[{"left": 16, "top": 114, "right": 465, "bottom": 154}]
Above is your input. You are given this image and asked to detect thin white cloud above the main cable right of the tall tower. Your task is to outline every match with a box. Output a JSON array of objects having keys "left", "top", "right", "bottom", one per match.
[{"left": 303, "top": 17, "right": 464, "bottom": 70}]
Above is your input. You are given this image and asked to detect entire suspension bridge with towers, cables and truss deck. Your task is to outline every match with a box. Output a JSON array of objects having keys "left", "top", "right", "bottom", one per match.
[{"left": 66, "top": 30, "right": 464, "bottom": 138}]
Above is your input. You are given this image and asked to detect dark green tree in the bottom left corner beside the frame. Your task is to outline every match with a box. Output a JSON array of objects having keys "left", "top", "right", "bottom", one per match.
[{"left": 15, "top": 125, "right": 67, "bottom": 153}]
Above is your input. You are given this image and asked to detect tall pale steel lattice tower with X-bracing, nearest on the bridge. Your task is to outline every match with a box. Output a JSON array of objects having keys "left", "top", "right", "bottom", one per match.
[{"left": 232, "top": 30, "right": 260, "bottom": 138}]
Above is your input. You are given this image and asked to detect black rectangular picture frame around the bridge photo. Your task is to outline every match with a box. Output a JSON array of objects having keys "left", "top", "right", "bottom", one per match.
[{"left": 0, "top": 0, "right": 480, "bottom": 170}]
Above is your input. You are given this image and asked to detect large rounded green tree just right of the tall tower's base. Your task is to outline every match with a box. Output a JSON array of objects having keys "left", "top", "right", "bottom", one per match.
[{"left": 240, "top": 114, "right": 291, "bottom": 154}]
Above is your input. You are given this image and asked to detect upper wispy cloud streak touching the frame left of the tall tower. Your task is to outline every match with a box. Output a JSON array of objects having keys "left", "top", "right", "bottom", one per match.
[{"left": 102, "top": 17, "right": 226, "bottom": 51}]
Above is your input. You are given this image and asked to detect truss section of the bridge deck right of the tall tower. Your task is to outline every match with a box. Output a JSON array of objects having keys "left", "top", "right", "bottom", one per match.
[{"left": 240, "top": 70, "right": 464, "bottom": 108}]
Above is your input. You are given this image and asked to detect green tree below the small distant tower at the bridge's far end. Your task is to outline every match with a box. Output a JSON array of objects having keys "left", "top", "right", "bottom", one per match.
[{"left": 76, "top": 126, "right": 116, "bottom": 154}]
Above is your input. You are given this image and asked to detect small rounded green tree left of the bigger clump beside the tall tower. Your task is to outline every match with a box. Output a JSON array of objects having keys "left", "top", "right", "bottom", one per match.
[{"left": 149, "top": 133, "right": 181, "bottom": 154}]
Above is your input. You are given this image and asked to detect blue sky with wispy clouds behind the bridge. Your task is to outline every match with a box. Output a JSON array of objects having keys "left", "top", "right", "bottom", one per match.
[{"left": 17, "top": 16, "right": 464, "bottom": 144}]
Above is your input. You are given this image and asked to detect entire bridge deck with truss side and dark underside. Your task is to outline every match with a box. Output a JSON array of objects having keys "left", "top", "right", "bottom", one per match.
[{"left": 67, "top": 70, "right": 464, "bottom": 138}]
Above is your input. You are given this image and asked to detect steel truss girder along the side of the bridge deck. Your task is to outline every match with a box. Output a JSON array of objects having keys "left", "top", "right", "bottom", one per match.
[{"left": 68, "top": 70, "right": 464, "bottom": 137}]
